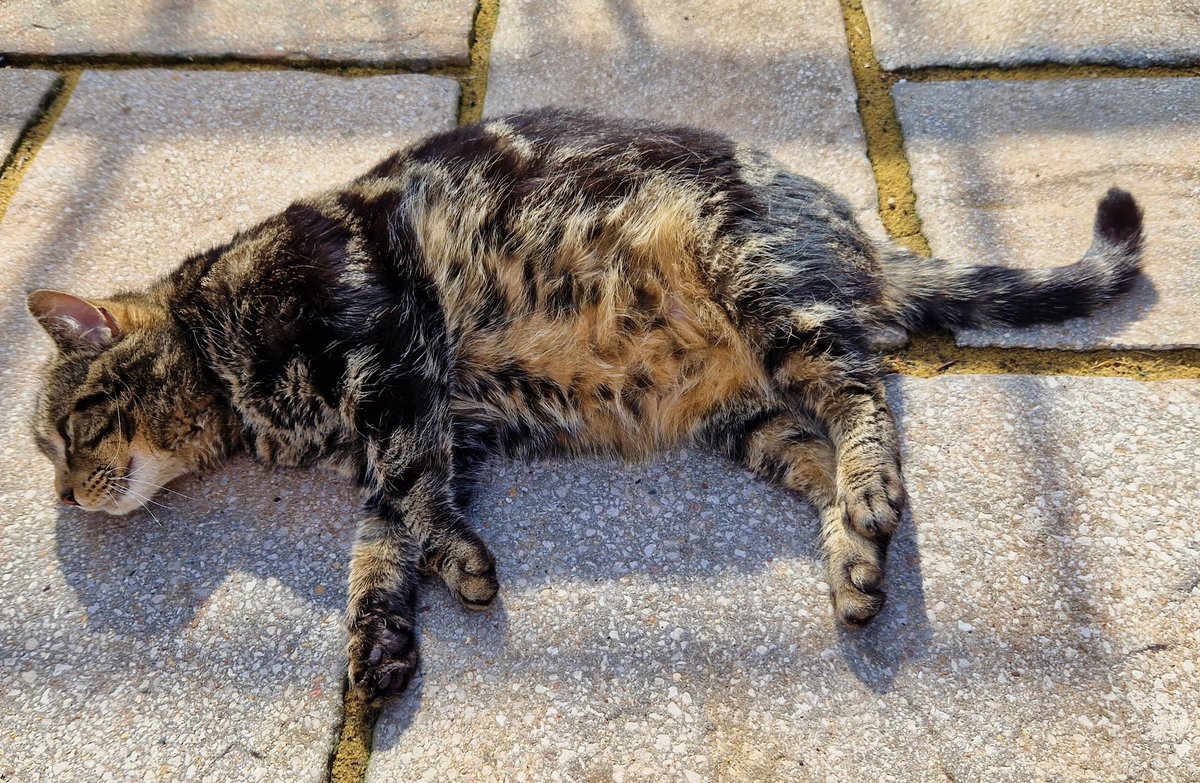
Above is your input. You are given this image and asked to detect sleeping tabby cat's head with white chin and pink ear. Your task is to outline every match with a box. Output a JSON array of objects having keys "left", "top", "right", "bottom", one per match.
[{"left": 26, "top": 291, "right": 239, "bottom": 515}]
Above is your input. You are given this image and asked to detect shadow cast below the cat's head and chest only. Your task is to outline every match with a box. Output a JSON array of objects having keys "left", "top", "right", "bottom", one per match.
[{"left": 55, "top": 459, "right": 358, "bottom": 641}]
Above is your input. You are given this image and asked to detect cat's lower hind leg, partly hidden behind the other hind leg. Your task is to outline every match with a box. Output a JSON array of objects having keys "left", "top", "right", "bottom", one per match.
[{"left": 709, "top": 408, "right": 888, "bottom": 627}]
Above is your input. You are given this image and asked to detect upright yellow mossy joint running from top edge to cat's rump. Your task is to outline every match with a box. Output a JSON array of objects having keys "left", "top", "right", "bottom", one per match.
[{"left": 841, "top": 0, "right": 930, "bottom": 256}]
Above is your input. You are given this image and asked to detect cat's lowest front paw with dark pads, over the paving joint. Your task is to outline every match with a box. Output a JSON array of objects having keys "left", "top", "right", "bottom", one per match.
[{"left": 348, "top": 614, "right": 418, "bottom": 701}]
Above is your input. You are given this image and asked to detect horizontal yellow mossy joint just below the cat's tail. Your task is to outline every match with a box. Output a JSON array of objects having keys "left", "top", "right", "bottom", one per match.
[{"left": 883, "top": 334, "right": 1200, "bottom": 381}]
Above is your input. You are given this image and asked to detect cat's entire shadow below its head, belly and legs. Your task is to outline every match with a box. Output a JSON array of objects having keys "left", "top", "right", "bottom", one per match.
[{"left": 56, "top": 425, "right": 930, "bottom": 696}]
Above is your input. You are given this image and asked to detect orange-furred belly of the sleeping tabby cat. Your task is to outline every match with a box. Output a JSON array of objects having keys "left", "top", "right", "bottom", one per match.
[{"left": 454, "top": 289, "right": 769, "bottom": 459}]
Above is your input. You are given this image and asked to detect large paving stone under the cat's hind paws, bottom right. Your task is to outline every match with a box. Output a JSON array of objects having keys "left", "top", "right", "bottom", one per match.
[{"left": 367, "top": 376, "right": 1200, "bottom": 783}]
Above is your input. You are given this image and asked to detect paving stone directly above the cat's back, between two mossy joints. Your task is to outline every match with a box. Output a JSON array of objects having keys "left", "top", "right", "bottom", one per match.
[{"left": 485, "top": 0, "right": 882, "bottom": 231}]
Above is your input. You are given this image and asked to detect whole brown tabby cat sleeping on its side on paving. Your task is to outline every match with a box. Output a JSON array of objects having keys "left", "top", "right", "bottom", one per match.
[{"left": 21, "top": 109, "right": 1144, "bottom": 700}]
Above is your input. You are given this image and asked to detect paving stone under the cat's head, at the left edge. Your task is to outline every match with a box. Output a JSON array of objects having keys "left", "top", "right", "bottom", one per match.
[{"left": 0, "top": 70, "right": 458, "bottom": 783}]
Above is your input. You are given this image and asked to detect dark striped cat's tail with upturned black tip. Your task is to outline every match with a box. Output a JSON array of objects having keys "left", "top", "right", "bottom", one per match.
[{"left": 881, "top": 187, "right": 1144, "bottom": 329}]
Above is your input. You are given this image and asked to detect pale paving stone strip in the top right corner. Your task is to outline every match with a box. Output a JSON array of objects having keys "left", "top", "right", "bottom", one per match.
[{"left": 863, "top": 0, "right": 1200, "bottom": 68}]
